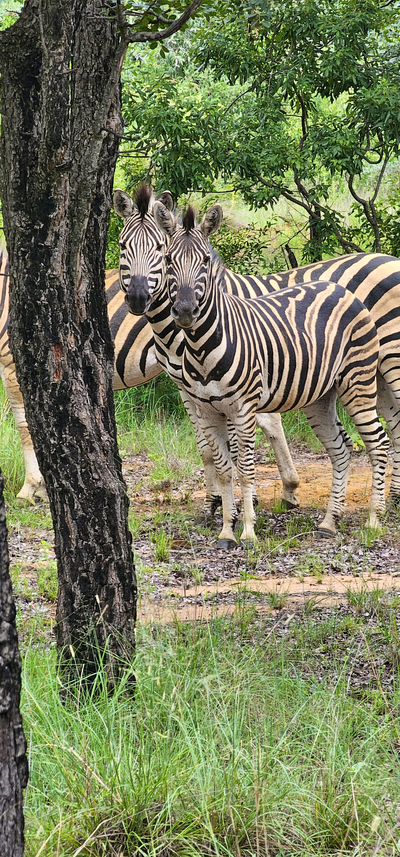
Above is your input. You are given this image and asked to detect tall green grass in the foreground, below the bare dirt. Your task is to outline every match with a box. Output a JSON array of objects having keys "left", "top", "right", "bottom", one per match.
[{"left": 23, "top": 616, "right": 400, "bottom": 857}]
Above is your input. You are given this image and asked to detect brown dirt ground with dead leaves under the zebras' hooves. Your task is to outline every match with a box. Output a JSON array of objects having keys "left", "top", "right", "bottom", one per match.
[{"left": 124, "top": 452, "right": 400, "bottom": 623}]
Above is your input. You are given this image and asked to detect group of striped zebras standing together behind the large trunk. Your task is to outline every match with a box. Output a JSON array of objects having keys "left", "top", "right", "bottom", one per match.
[{"left": 0, "top": 185, "right": 400, "bottom": 547}]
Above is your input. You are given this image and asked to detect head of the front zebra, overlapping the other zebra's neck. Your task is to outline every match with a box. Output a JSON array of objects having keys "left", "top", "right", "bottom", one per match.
[{"left": 154, "top": 202, "right": 223, "bottom": 328}]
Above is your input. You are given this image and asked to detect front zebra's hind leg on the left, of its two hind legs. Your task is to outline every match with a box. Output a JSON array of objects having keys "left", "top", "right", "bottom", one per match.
[{"left": 303, "top": 389, "right": 352, "bottom": 537}]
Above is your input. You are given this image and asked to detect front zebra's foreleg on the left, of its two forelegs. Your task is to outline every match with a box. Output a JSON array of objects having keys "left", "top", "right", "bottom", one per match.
[{"left": 197, "top": 406, "right": 237, "bottom": 550}]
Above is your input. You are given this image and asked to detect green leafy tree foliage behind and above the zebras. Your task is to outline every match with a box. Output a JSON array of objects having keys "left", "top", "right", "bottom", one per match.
[{"left": 120, "top": 0, "right": 400, "bottom": 261}]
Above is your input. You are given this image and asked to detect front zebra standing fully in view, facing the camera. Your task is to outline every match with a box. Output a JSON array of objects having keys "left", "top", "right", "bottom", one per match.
[{"left": 145, "top": 202, "right": 389, "bottom": 548}]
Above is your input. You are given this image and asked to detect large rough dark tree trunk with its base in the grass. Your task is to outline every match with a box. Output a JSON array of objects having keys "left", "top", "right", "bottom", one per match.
[{"left": 0, "top": 0, "right": 136, "bottom": 681}]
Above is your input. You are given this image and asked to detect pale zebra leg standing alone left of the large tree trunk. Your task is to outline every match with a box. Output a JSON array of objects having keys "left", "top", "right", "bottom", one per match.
[{"left": 0, "top": 362, "right": 47, "bottom": 503}]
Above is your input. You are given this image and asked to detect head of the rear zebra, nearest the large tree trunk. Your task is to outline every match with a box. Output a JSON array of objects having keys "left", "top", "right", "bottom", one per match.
[{"left": 113, "top": 183, "right": 174, "bottom": 315}]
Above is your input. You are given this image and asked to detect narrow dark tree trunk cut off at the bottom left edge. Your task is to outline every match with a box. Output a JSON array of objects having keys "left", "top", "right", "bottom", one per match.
[{"left": 0, "top": 474, "right": 28, "bottom": 857}]
